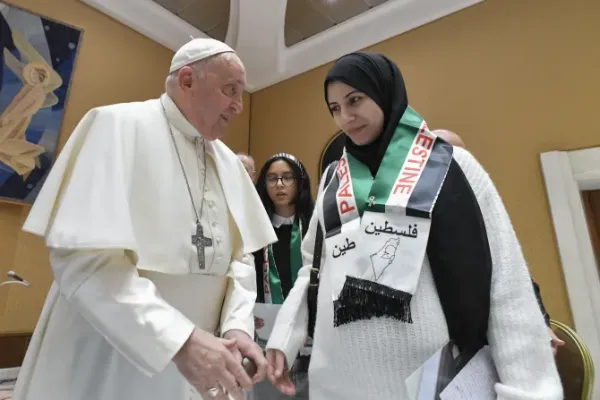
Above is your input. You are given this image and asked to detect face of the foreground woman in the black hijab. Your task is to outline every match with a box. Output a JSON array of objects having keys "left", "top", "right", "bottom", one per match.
[{"left": 327, "top": 82, "right": 383, "bottom": 146}]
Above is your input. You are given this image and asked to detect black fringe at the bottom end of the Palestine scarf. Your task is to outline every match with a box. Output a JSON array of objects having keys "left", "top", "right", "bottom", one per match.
[{"left": 333, "top": 276, "right": 413, "bottom": 327}]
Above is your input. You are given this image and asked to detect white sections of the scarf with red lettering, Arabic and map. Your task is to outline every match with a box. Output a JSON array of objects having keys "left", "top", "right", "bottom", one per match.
[{"left": 325, "top": 123, "right": 436, "bottom": 300}]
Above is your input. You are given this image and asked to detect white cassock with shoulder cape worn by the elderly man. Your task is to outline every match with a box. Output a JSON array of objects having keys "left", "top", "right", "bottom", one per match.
[{"left": 14, "top": 89, "right": 276, "bottom": 400}]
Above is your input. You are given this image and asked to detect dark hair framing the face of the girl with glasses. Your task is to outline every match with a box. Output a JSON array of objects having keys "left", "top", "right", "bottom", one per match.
[{"left": 256, "top": 153, "right": 314, "bottom": 236}]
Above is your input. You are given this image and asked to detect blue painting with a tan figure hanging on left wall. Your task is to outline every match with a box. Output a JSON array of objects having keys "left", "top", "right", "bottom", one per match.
[{"left": 0, "top": 2, "right": 82, "bottom": 204}]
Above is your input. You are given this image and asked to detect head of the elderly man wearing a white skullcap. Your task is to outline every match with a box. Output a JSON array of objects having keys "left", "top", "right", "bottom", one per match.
[{"left": 165, "top": 39, "right": 246, "bottom": 140}]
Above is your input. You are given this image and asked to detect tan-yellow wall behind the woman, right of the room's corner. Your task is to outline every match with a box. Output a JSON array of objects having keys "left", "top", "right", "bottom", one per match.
[{"left": 250, "top": 0, "right": 600, "bottom": 323}]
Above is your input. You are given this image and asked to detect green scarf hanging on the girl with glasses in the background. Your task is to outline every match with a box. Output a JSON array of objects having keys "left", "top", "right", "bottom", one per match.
[{"left": 263, "top": 217, "right": 302, "bottom": 304}]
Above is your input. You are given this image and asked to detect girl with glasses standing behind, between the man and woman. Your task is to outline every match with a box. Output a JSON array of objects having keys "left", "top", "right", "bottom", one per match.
[{"left": 252, "top": 153, "right": 314, "bottom": 400}]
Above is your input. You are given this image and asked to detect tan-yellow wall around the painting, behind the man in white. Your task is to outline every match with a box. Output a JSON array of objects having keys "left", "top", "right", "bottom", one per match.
[{"left": 0, "top": 0, "right": 250, "bottom": 333}]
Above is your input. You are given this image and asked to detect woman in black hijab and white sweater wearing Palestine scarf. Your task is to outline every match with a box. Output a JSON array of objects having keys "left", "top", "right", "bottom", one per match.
[{"left": 267, "top": 52, "right": 562, "bottom": 400}]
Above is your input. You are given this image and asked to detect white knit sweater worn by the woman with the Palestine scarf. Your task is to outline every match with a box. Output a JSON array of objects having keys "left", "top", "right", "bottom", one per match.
[{"left": 267, "top": 148, "right": 562, "bottom": 400}]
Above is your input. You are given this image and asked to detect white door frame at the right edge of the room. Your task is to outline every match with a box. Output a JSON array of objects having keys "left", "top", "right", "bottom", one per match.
[{"left": 540, "top": 147, "right": 600, "bottom": 399}]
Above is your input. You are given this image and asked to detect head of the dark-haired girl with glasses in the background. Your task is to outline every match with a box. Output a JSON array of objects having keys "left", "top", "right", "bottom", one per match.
[{"left": 256, "top": 153, "right": 313, "bottom": 233}]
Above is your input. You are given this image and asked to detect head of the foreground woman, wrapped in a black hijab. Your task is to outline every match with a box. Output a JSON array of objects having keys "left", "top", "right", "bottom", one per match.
[{"left": 325, "top": 52, "right": 408, "bottom": 146}]
